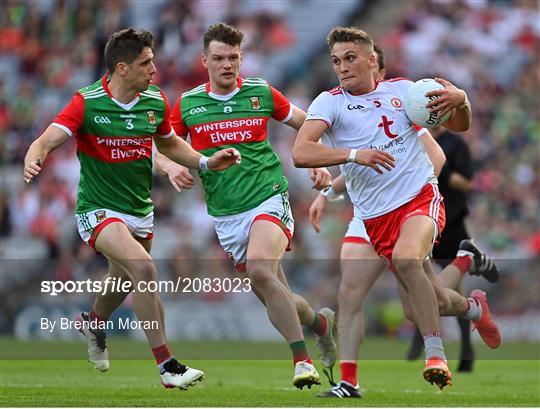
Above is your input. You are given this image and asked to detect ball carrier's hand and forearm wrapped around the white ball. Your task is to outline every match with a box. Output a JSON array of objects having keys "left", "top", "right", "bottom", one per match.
[{"left": 426, "top": 78, "right": 472, "bottom": 132}]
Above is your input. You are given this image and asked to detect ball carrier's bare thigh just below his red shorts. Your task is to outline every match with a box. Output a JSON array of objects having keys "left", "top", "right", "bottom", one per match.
[{"left": 392, "top": 215, "right": 436, "bottom": 262}]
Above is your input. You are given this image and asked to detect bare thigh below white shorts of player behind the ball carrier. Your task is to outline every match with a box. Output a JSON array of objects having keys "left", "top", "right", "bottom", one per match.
[{"left": 340, "top": 242, "right": 384, "bottom": 302}]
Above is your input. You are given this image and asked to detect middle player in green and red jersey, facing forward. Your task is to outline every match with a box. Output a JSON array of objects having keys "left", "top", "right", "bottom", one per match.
[{"left": 171, "top": 23, "right": 337, "bottom": 388}]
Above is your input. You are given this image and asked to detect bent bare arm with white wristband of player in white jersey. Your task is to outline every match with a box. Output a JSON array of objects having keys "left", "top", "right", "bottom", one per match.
[{"left": 292, "top": 119, "right": 395, "bottom": 173}]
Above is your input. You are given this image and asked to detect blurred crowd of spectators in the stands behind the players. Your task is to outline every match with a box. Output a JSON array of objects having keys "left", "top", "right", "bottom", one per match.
[{"left": 0, "top": 0, "right": 540, "bottom": 336}]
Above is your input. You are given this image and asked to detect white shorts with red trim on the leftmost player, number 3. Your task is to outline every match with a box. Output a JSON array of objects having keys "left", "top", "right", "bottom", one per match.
[{"left": 75, "top": 209, "right": 154, "bottom": 248}]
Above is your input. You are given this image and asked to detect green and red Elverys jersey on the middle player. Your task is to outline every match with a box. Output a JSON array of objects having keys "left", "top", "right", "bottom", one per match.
[{"left": 171, "top": 78, "right": 292, "bottom": 216}]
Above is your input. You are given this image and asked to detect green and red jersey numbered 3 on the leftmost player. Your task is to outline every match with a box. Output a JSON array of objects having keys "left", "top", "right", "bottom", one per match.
[{"left": 52, "top": 74, "right": 174, "bottom": 217}]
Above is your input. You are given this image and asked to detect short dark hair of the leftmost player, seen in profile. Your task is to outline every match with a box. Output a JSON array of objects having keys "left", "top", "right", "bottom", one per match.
[{"left": 105, "top": 28, "right": 154, "bottom": 74}]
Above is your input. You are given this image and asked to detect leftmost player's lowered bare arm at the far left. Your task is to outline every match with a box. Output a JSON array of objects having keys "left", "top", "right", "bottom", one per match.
[{"left": 23, "top": 125, "right": 70, "bottom": 183}]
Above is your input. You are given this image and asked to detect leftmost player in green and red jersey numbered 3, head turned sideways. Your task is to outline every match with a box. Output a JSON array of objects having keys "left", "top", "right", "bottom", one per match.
[{"left": 24, "top": 29, "right": 240, "bottom": 388}]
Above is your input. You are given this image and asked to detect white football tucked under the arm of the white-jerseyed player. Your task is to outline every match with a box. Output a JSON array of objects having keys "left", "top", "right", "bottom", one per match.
[{"left": 405, "top": 78, "right": 452, "bottom": 128}]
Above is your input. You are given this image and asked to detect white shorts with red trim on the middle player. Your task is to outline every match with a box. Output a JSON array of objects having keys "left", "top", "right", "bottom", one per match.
[{"left": 213, "top": 192, "right": 294, "bottom": 271}]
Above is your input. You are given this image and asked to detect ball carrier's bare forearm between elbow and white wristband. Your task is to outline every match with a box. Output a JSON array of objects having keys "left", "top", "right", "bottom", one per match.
[{"left": 292, "top": 140, "right": 350, "bottom": 168}]
